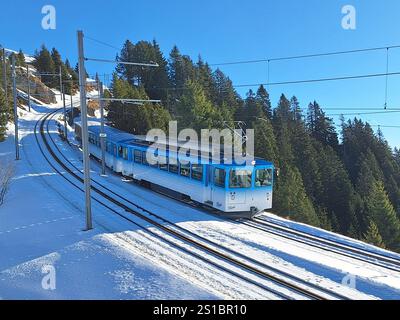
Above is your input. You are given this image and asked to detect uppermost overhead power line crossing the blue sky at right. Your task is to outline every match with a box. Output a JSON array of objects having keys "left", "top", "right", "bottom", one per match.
[{"left": 210, "top": 45, "right": 400, "bottom": 66}]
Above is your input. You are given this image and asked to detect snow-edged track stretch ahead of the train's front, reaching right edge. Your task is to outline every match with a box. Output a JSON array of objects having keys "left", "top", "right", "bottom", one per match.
[{"left": 243, "top": 216, "right": 400, "bottom": 272}]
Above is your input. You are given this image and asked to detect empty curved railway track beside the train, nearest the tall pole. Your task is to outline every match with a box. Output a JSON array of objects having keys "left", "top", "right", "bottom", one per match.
[{"left": 35, "top": 110, "right": 349, "bottom": 300}]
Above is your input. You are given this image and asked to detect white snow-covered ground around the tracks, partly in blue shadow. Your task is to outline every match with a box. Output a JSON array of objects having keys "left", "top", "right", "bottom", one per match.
[{"left": 0, "top": 96, "right": 400, "bottom": 299}]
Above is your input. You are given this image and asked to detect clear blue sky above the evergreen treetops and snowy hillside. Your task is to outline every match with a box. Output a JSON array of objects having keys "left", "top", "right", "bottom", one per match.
[{"left": 0, "top": 0, "right": 400, "bottom": 146}]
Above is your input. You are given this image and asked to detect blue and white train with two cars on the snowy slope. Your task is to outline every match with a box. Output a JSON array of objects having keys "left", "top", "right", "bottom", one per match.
[{"left": 75, "top": 121, "right": 274, "bottom": 218}]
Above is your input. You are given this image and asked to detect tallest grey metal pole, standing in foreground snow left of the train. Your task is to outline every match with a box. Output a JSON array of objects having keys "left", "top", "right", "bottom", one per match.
[{"left": 77, "top": 31, "right": 93, "bottom": 230}]
